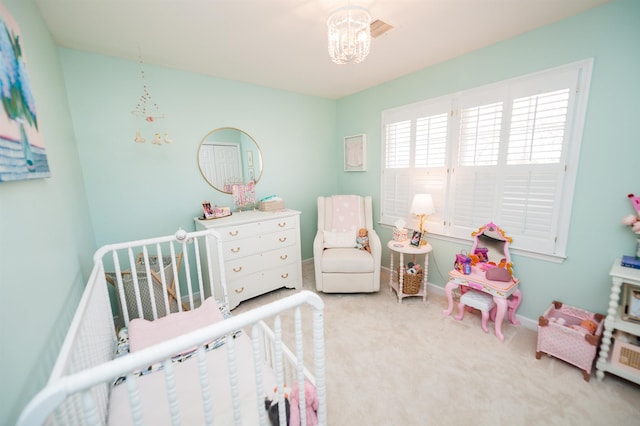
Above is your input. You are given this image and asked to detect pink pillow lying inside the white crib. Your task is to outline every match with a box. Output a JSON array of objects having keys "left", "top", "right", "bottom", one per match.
[{"left": 129, "top": 297, "right": 224, "bottom": 352}]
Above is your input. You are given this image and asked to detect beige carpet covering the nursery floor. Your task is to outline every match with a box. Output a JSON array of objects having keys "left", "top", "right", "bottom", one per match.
[{"left": 233, "top": 262, "right": 640, "bottom": 425}]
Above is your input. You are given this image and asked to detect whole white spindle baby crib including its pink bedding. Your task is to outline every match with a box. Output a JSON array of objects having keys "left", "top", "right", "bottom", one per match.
[{"left": 18, "top": 230, "right": 326, "bottom": 425}]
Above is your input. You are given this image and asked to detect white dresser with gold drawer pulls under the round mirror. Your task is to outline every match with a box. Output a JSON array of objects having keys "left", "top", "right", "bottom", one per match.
[{"left": 195, "top": 210, "right": 302, "bottom": 309}]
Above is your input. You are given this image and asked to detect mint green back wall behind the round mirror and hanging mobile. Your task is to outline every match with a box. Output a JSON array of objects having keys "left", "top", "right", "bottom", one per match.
[{"left": 59, "top": 48, "right": 338, "bottom": 251}]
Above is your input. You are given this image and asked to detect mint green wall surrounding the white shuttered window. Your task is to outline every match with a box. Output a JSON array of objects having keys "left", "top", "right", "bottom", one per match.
[{"left": 337, "top": 0, "right": 640, "bottom": 319}]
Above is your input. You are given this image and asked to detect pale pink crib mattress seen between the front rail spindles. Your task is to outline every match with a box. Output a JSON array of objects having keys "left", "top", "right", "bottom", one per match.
[{"left": 108, "top": 333, "right": 276, "bottom": 426}]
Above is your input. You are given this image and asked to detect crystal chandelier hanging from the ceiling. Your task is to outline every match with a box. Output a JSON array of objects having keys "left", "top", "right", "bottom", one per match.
[{"left": 327, "top": 5, "right": 371, "bottom": 64}]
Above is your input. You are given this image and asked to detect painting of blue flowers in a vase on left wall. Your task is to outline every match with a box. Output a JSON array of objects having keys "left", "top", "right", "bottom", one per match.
[{"left": 0, "top": 3, "right": 50, "bottom": 182}]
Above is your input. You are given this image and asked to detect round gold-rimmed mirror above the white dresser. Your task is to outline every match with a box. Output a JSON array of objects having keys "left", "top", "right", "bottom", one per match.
[{"left": 198, "top": 127, "right": 262, "bottom": 194}]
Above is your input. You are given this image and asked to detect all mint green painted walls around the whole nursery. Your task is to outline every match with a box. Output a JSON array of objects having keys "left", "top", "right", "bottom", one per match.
[{"left": 0, "top": 0, "right": 640, "bottom": 424}]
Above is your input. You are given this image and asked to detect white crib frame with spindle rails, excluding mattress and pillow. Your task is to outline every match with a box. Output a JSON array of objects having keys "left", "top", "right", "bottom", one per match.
[{"left": 18, "top": 230, "right": 327, "bottom": 426}]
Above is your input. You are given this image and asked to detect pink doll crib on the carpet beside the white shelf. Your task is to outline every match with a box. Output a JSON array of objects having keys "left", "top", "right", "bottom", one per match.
[{"left": 536, "top": 301, "right": 605, "bottom": 381}]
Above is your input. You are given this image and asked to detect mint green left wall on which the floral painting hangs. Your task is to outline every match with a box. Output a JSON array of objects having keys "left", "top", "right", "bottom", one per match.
[{"left": 0, "top": 0, "right": 96, "bottom": 424}]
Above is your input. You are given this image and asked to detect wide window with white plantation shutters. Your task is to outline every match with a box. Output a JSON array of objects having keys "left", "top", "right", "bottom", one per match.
[{"left": 381, "top": 60, "right": 592, "bottom": 257}]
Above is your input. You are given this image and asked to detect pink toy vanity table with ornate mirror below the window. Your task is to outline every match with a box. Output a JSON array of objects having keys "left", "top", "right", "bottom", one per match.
[{"left": 442, "top": 222, "right": 522, "bottom": 340}]
